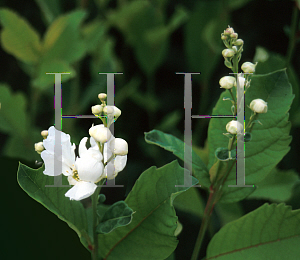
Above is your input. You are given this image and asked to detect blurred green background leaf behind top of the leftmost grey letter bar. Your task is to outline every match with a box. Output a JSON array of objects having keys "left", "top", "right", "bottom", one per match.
[{"left": 32, "top": 60, "right": 76, "bottom": 89}]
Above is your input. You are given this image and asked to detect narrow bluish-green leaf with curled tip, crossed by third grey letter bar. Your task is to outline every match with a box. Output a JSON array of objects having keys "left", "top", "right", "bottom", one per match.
[{"left": 145, "top": 130, "right": 210, "bottom": 188}]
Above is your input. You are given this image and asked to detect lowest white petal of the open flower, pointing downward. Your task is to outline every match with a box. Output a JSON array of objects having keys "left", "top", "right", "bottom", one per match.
[{"left": 65, "top": 181, "right": 97, "bottom": 200}]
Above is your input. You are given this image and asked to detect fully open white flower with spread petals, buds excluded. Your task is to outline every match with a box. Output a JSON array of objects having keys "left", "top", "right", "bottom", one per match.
[{"left": 41, "top": 126, "right": 105, "bottom": 200}]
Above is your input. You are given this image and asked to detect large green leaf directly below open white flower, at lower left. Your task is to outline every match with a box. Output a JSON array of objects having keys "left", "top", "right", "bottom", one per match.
[{"left": 18, "top": 163, "right": 88, "bottom": 247}]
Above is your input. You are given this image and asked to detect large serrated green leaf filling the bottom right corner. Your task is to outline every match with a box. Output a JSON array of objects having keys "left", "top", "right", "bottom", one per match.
[{"left": 206, "top": 203, "right": 300, "bottom": 260}]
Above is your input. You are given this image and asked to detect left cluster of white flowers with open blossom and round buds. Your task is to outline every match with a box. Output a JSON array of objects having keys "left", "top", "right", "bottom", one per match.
[{"left": 35, "top": 93, "right": 128, "bottom": 200}]
